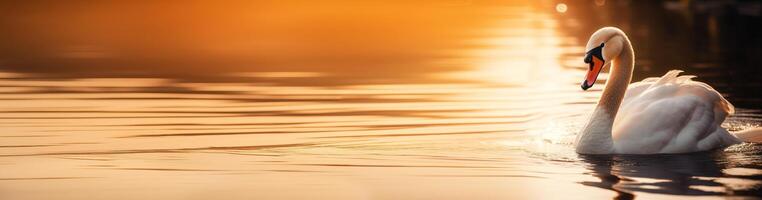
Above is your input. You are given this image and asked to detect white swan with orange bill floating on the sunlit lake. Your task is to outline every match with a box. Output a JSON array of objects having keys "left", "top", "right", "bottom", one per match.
[{"left": 575, "top": 27, "right": 762, "bottom": 154}]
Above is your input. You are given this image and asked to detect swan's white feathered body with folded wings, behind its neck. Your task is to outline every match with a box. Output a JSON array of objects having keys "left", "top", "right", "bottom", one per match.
[{"left": 612, "top": 72, "right": 737, "bottom": 153}]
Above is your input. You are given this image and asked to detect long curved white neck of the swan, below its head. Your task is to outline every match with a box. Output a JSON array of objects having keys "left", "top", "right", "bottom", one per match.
[{"left": 577, "top": 38, "right": 635, "bottom": 154}]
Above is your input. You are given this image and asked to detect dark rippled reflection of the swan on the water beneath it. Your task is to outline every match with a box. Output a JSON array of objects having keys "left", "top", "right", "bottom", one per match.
[{"left": 580, "top": 150, "right": 762, "bottom": 199}]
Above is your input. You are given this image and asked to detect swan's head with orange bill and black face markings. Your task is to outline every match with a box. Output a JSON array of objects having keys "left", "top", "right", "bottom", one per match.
[{"left": 582, "top": 27, "right": 626, "bottom": 90}]
